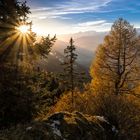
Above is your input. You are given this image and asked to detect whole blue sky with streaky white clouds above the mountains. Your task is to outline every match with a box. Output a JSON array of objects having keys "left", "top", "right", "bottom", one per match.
[{"left": 24, "top": 0, "right": 140, "bottom": 34}]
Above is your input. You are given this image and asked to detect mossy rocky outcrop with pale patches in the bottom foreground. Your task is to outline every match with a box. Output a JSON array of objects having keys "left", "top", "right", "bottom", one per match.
[{"left": 0, "top": 112, "right": 118, "bottom": 140}]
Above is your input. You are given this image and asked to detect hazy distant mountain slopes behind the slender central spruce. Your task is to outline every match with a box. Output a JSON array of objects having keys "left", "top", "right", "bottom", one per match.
[{"left": 37, "top": 31, "right": 107, "bottom": 73}]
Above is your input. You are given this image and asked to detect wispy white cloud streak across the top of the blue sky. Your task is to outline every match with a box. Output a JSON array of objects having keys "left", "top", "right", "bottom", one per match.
[{"left": 31, "top": 0, "right": 112, "bottom": 18}]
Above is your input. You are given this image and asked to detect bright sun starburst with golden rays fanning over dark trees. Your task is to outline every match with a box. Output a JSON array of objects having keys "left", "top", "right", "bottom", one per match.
[{"left": 0, "top": 22, "right": 33, "bottom": 66}]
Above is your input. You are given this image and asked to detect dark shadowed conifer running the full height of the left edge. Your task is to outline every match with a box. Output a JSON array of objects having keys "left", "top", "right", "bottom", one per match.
[{"left": 0, "top": 0, "right": 34, "bottom": 127}]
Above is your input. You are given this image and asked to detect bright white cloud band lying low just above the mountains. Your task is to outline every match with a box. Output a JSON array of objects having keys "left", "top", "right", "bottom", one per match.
[{"left": 34, "top": 20, "right": 112, "bottom": 35}]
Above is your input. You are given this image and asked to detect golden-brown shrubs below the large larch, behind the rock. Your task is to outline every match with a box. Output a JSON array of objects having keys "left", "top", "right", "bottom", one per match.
[{"left": 51, "top": 91, "right": 140, "bottom": 140}]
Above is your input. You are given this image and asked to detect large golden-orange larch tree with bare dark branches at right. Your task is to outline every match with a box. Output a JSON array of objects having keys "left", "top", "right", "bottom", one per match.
[{"left": 91, "top": 18, "right": 140, "bottom": 95}]
